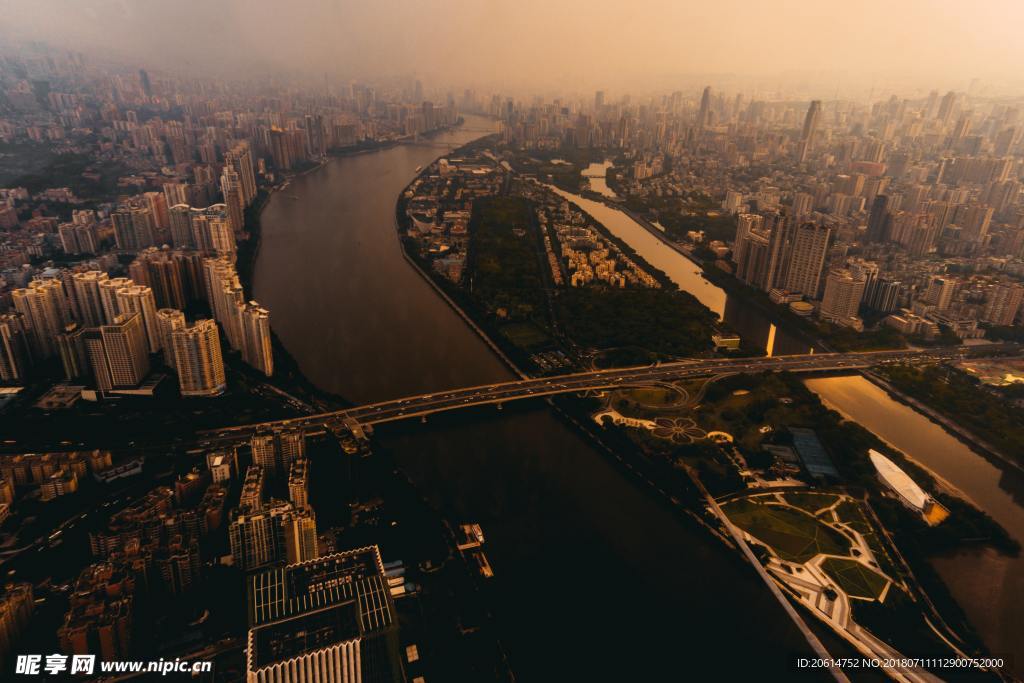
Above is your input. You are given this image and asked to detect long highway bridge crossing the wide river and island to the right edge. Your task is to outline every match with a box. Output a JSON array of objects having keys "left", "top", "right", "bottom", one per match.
[{"left": 200, "top": 344, "right": 1021, "bottom": 444}]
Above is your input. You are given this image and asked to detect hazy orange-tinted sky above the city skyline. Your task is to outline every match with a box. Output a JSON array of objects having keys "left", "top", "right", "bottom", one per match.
[{"left": 0, "top": 0, "right": 1024, "bottom": 91}]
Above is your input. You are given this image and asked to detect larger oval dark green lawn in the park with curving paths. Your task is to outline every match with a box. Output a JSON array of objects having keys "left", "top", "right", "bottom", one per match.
[{"left": 723, "top": 499, "right": 850, "bottom": 562}]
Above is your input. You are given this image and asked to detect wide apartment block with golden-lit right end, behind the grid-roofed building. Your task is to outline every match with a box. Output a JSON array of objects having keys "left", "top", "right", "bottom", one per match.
[{"left": 228, "top": 501, "right": 317, "bottom": 571}]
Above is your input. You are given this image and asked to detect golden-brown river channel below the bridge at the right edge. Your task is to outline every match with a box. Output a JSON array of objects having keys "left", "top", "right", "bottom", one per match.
[{"left": 806, "top": 376, "right": 1024, "bottom": 671}]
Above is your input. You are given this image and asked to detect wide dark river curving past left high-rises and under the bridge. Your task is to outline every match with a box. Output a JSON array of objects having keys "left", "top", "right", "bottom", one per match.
[{"left": 254, "top": 117, "right": 809, "bottom": 681}]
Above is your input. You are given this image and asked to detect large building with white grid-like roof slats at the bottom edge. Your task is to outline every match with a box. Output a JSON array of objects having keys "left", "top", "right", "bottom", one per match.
[{"left": 246, "top": 546, "right": 406, "bottom": 683}]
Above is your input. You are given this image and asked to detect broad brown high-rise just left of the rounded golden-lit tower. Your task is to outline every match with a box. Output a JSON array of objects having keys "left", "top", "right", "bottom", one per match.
[{"left": 85, "top": 313, "right": 150, "bottom": 391}]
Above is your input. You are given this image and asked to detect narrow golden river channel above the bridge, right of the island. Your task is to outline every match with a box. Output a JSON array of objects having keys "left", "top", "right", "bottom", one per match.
[{"left": 549, "top": 185, "right": 810, "bottom": 355}]
